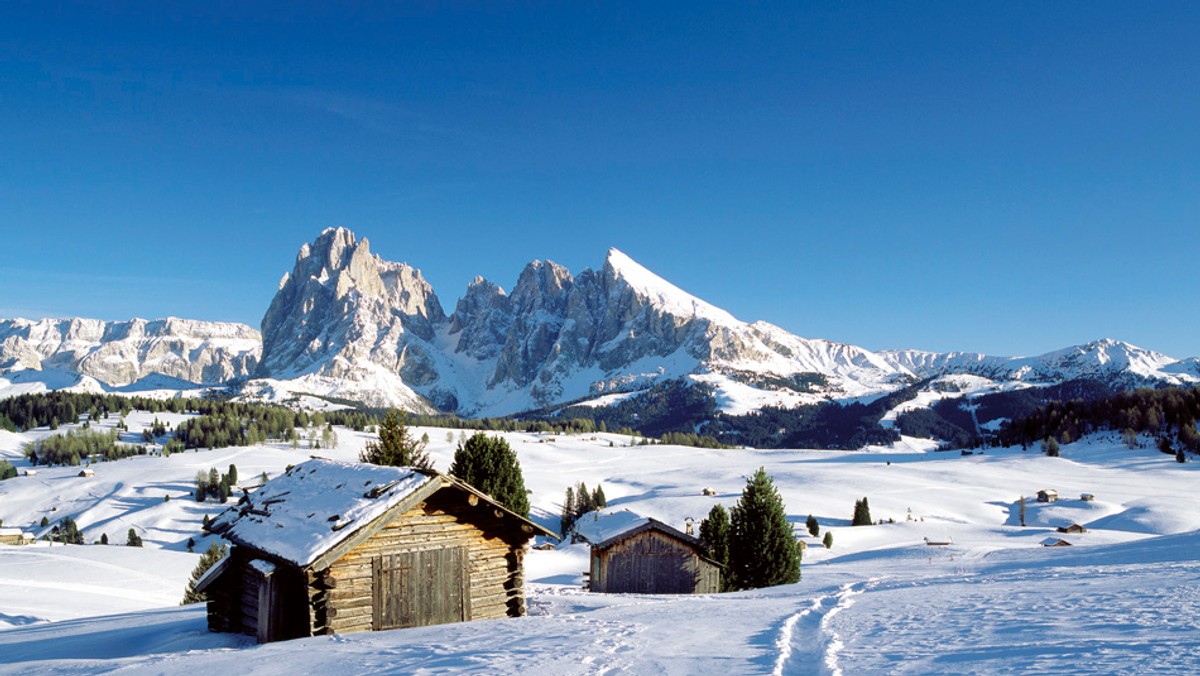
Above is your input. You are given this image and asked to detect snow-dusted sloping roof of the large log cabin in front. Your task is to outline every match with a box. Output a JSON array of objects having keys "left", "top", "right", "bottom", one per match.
[{"left": 209, "top": 457, "right": 554, "bottom": 568}]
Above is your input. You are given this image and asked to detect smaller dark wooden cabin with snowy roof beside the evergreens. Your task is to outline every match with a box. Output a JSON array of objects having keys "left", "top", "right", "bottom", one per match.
[{"left": 576, "top": 510, "right": 721, "bottom": 594}]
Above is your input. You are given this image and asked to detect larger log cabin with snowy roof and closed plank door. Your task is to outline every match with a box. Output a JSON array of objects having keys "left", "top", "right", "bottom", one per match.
[{"left": 197, "top": 459, "right": 556, "bottom": 642}]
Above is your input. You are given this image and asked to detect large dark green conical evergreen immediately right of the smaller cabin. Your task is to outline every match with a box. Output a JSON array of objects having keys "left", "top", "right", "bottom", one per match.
[{"left": 730, "top": 467, "right": 800, "bottom": 590}]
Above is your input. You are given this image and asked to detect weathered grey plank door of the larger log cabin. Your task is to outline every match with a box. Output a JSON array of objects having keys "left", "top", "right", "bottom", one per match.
[{"left": 371, "top": 548, "right": 470, "bottom": 630}]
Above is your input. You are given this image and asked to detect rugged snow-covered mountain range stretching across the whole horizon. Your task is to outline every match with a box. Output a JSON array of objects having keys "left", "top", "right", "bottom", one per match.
[{"left": 0, "top": 228, "right": 1200, "bottom": 415}]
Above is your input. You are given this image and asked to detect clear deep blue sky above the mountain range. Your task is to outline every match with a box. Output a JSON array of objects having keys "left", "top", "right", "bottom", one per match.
[{"left": 0, "top": 2, "right": 1200, "bottom": 357}]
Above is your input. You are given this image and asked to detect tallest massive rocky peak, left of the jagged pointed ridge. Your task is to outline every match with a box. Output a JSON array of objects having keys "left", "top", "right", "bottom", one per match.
[{"left": 258, "top": 228, "right": 445, "bottom": 385}]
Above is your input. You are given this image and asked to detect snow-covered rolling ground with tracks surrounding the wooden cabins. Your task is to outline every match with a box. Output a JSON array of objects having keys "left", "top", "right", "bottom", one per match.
[{"left": 0, "top": 413, "right": 1200, "bottom": 675}]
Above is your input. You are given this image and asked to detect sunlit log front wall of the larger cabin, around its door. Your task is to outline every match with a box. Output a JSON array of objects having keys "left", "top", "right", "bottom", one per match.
[{"left": 308, "top": 490, "right": 529, "bottom": 634}]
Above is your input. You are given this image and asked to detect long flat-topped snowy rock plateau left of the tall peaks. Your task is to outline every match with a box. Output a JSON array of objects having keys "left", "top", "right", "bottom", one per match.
[{"left": 0, "top": 318, "right": 260, "bottom": 385}]
